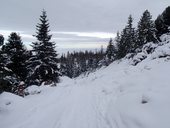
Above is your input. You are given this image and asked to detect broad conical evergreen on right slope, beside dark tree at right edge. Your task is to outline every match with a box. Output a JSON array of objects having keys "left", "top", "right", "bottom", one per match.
[{"left": 135, "top": 10, "right": 156, "bottom": 48}]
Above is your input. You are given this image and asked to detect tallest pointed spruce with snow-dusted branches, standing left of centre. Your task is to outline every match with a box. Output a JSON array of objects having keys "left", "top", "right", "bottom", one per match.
[{"left": 28, "top": 10, "right": 60, "bottom": 85}]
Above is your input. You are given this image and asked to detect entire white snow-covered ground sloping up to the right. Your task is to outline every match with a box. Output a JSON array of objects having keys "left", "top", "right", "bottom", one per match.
[{"left": 0, "top": 34, "right": 170, "bottom": 128}]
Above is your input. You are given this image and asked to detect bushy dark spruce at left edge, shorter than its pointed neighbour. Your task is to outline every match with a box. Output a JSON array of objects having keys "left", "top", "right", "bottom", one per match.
[{"left": 0, "top": 33, "right": 25, "bottom": 93}]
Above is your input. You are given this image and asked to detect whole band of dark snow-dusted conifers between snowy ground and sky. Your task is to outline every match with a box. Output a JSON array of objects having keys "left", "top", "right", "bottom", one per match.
[{"left": 0, "top": 6, "right": 170, "bottom": 96}]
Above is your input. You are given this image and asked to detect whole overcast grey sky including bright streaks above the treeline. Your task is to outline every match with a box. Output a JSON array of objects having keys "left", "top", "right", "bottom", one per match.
[{"left": 0, "top": 0, "right": 170, "bottom": 52}]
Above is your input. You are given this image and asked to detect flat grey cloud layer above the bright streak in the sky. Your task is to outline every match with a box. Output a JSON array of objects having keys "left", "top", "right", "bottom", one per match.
[{"left": 0, "top": 0, "right": 169, "bottom": 32}]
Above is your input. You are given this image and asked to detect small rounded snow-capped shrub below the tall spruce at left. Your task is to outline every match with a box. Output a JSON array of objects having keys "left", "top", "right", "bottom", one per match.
[{"left": 24, "top": 85, "right": 41, "bottom": 95}]
